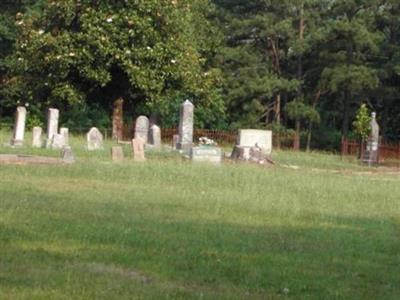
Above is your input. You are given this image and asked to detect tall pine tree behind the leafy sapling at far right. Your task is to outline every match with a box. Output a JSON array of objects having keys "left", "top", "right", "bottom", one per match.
[{"left": 320, "top": 0, "right": 383, "bottom": 136}]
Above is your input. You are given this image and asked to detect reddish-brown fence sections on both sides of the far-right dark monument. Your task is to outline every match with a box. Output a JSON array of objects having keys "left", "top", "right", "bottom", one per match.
[{"left": 341, "top": 139, "right": 400, "bottom": 161}]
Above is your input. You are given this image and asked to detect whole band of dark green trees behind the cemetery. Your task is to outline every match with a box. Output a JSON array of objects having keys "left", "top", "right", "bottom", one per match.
[{"left": 0, "top": 0, "right": 400, "bottom": 149}]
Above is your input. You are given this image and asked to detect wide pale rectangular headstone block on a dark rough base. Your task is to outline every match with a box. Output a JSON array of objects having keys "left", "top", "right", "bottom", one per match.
[{"left": 237, "top": 129, "right": 272, "bottom": 155}]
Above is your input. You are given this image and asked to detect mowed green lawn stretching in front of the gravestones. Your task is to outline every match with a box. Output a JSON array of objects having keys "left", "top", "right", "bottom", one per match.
[{"left": 0, "top": 132, "right": 400, "bottom": 299}]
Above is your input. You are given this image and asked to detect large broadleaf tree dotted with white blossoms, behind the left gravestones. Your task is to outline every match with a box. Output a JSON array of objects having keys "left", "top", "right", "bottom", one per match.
[{"left": 3, "top": 0, "right": 223, "bottom": 126}]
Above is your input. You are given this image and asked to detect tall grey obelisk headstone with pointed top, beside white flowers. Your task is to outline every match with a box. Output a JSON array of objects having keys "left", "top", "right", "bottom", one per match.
[{"left": 178, "top": 100, "right": 194, "bottom": 153}]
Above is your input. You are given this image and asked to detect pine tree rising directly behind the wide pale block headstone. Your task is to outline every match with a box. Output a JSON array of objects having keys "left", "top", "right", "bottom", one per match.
[{"left": 215, "top": 0, "right": 299, "bottom": 127}]
